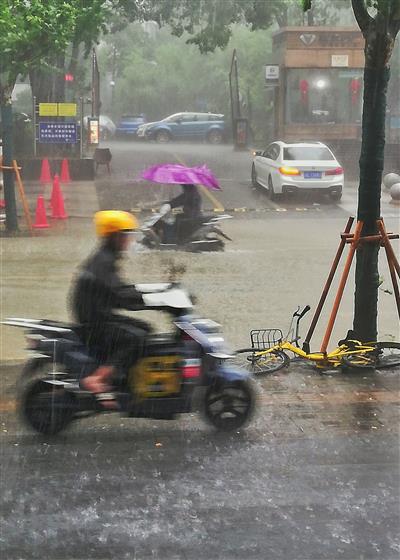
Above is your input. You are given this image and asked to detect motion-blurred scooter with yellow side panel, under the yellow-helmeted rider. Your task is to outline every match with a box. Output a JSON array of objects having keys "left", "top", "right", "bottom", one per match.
[{"left": 4, "top": 284, "right": 255, "bottom": 435}]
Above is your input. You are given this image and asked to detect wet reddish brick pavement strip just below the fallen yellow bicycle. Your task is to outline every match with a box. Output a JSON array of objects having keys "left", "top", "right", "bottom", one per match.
[{"left": 0, "top": 356, "right": 400, "bottom": 440}]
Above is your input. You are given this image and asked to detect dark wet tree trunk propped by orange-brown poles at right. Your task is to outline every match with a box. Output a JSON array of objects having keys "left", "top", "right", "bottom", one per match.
[{"left": 352, "top": 0, "right": 398, "bottom": 341}]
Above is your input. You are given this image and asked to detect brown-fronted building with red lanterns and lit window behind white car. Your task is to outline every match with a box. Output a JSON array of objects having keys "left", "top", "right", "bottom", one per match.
[{"left": 273, "top": 27, "right": 364, "bottom": 141}]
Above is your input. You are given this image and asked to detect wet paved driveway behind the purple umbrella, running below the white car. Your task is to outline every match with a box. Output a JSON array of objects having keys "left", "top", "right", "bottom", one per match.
[{"left": 96, "top": 141, "right": 399, "bottom": 218}]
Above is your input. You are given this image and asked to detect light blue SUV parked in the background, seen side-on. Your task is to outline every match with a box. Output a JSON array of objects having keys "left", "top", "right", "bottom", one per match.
[{"left": 137, "top": 112, "right": 225, "bottom": 144}]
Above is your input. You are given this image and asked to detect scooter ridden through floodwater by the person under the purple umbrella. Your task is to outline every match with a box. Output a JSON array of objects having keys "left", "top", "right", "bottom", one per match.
[{"left": 138, "top": 212, "right": 232, "bottom": 252}]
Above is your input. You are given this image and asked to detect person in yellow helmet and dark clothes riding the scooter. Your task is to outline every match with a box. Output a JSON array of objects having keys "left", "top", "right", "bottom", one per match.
[{"left": 72, "top": 210, "right": 150, "bottom": 409}]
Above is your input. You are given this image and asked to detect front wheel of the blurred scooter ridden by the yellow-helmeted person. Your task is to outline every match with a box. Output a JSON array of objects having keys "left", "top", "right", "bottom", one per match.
[{"left": 204, "top": 379, "right": 256, "bottom": 431}]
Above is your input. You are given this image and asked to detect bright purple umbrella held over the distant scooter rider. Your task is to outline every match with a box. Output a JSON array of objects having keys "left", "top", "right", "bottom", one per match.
[{"left": 141, "top": 163, "right": 222, "bottom": 191}]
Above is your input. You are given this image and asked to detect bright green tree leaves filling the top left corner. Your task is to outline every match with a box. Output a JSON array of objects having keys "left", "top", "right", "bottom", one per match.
[{"left": 0, "top": 0, "right": 115, "bottom": 101}]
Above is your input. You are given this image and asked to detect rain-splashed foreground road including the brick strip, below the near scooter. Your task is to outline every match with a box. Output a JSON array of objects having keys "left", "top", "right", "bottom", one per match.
[{"left": 0, "top": 364, "right": 400, "bottom": 560}]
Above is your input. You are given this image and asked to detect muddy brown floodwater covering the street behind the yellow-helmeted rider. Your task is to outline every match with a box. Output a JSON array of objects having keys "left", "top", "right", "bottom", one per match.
[{"left": 1, "top": 213, "right": 398, "bottom": 359}]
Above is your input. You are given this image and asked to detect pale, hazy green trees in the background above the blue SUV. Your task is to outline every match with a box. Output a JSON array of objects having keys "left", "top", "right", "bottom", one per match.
[{"left": 99, "top": 24, "right": 271, "bottom": 140}]
